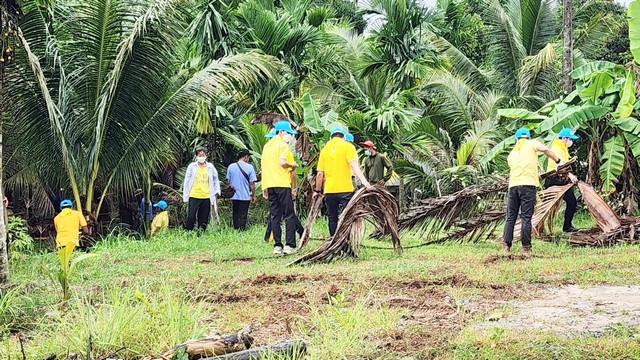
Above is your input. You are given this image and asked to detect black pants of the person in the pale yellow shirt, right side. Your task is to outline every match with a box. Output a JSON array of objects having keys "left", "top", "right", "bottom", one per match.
[{"left": 502, "top": 186, "right": 536, "bottom": 247}]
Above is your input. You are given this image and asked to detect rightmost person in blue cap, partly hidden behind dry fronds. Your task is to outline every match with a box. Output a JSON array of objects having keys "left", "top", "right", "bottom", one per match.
[{"left": 544, "top": 128, "right": 580, "bottom": 233}]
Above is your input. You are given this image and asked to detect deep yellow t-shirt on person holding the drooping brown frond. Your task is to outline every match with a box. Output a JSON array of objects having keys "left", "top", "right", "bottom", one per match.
[{"left": 318, "top": 137, "right": 358, "bottom": 194}]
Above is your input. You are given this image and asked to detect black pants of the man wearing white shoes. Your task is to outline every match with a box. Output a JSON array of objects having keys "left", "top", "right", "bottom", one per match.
[{"left": 267, "top": 188, "right": 296, "bottom": 248}]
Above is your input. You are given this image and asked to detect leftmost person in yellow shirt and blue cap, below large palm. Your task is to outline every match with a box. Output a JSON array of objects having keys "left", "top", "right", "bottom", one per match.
[{"left": 53, "top": 199, "right": 89, "bottom": 258}]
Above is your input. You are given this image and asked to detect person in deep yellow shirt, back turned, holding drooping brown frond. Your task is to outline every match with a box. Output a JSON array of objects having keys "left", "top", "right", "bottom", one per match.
[{"left": 314, "top": 127, "right": 371, "bottom": 236}]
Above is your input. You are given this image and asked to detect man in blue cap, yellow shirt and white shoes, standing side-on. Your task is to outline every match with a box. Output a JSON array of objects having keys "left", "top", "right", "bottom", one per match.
[{"left": 261, "top": 120, "right": 298, "bottom": 255}]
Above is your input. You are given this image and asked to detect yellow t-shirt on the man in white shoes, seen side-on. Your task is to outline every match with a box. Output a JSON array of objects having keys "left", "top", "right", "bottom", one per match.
[{"left": 261, "top": 136, "right": 293, "bottom": 189}]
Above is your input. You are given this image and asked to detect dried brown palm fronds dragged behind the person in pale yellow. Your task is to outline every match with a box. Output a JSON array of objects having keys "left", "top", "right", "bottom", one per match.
[{"left": 398, "top": 177, "right": 508, "bottom": 245}]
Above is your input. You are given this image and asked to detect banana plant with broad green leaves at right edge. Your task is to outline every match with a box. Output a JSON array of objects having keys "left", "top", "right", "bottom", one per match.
[{"left": 482, "top": 61, "right": 640, "bottom": 200}]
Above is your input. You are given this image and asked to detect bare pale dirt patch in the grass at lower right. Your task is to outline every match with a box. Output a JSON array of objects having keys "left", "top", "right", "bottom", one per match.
[{"left": 478, "top": 285, "right": 640, "bottom": 336}]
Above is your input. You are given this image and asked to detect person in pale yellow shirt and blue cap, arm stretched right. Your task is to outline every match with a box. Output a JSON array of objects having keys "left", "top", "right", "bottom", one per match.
[{"left": 502, "top": 128, "right": 560, "bottom": 252}]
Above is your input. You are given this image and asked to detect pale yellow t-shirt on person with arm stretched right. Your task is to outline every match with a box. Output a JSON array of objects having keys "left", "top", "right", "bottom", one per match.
[{"left": 507, "top": 139, "right": 541, "bottom": 187}]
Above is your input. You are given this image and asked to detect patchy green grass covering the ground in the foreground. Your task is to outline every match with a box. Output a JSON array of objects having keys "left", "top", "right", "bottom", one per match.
[{"left": 0, "top": 212, "right": 640, "bottom": 359}]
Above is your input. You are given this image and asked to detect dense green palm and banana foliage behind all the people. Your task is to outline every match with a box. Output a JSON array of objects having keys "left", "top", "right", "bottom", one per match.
[{"left": 2, "top": 0, "right": 640, "bottom": 236}]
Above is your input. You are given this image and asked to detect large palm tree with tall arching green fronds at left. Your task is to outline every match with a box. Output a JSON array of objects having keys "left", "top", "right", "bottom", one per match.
[{"left": 7, "top": 0, "right": 274, "bottom": 221}]
